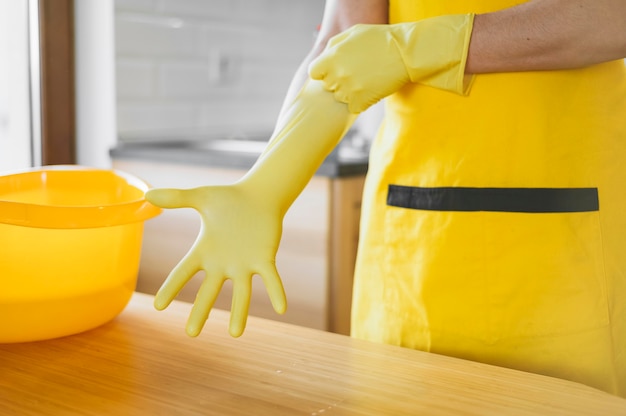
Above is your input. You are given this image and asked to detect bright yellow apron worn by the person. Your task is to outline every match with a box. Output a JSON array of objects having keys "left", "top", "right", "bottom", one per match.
[{"left": 352, "top": 0, "right": 626, "bottom": 396}]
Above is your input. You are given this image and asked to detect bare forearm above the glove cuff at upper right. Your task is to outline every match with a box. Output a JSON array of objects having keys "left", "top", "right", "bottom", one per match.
[{"left": 466, "top": 0, "right": 626, "bottom": 73}]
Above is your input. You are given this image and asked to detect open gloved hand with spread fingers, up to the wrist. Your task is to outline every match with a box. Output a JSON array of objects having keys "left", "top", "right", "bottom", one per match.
[{"left": 146, "top": 184, "right": 287, "bottom": 337}]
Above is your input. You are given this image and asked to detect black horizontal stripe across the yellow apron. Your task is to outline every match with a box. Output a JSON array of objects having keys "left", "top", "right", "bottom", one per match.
[{"left": 387, "top": 185, "right": 599, "bottom": 213}]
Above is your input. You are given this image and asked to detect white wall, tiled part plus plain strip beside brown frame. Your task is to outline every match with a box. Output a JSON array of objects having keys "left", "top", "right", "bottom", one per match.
[{"left": 73, "top": 0, "right": 379, "bottom": 167}]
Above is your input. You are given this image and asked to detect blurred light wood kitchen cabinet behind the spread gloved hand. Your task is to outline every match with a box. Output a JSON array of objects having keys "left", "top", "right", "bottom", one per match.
[{"left": 113, "top": 152, "right": 364, "bottom": 334}]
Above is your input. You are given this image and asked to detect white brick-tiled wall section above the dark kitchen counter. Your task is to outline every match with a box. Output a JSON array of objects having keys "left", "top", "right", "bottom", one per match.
[{"left": 115, "top": 0, "right": 324, "bottom": 140}]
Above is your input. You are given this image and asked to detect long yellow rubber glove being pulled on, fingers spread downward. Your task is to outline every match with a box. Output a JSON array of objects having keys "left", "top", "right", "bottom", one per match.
[{"left": 146, "top": 81, "right": 355, "bottom": 337}]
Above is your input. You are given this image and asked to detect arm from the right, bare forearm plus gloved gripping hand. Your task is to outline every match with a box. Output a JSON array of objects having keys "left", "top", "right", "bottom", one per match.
[{"left": 310, "top": 0, "right": 626, "bottom": 112}]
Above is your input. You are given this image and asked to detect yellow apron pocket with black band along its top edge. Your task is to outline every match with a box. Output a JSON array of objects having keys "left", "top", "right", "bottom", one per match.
[{"left": 385, "top": 185, "right": 608, "bottom": 343}]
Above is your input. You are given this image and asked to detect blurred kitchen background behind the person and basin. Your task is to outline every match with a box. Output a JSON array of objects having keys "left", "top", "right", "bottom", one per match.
[{"left": 0, "top": 0, "right": 382, "bottom": 333}]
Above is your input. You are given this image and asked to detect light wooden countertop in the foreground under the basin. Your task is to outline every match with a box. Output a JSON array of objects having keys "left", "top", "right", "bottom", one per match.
[{"left": 0, "top": 294, "right": 626, "bottom": 416}]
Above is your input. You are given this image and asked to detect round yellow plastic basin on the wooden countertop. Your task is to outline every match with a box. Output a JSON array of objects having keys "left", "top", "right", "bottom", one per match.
[{"left": 0, "top": 166, "right": 161, "bottom": 343}]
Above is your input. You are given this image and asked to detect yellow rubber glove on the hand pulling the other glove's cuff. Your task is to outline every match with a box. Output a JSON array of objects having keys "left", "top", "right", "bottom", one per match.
[{"left": 309, "top": 14, "right": 474, "bottom": 113}]
